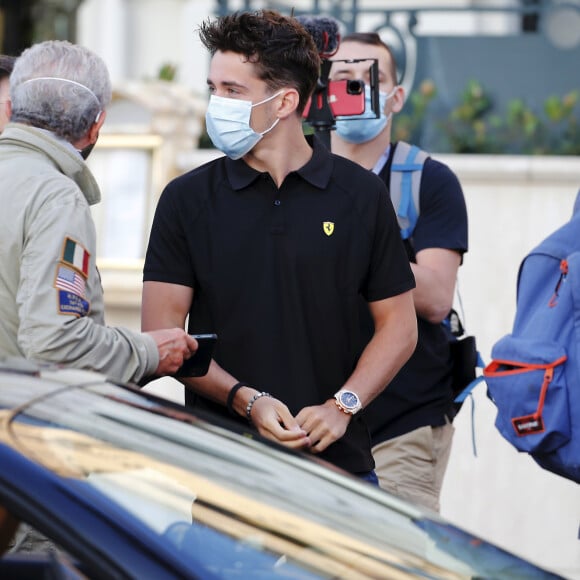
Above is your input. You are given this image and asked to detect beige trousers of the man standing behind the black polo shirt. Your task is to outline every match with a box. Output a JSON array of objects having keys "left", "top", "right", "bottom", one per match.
[{"left": 373, "top": 423, "right": 455, "bottom": 512}]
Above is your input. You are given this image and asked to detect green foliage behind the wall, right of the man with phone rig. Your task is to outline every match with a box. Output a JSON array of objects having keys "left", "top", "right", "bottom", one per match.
[{"left": 393, "top": 80, "right": 580, "bottom": 155}]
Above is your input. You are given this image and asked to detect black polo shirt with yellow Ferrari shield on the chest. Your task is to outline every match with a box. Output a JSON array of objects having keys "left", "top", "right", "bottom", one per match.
[{"left": 144, "top": 137, "right": 414, "bottom": 473}]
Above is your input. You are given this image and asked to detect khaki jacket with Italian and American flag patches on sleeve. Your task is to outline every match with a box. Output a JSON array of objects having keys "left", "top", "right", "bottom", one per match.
[{"left": 0, "top": 123, "right": 159, "bottom": 382}]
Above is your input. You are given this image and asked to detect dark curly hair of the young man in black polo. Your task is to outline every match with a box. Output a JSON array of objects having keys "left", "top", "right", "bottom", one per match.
[{"left": 199, "top": 10, "right": 320, "bottom": 113}]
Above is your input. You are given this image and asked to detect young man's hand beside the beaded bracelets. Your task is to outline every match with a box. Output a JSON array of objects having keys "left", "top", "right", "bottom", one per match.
[{"left": 251, "top": 397, "right": 310, "bottom": 449}]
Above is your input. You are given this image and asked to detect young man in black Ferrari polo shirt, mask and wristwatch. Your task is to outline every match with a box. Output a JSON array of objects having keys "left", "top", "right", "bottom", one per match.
[{"left": 142, "top": 10, "right": 417, "bottom": 477}]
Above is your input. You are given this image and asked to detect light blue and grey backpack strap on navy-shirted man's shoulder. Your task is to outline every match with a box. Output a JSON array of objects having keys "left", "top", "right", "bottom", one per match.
[{"left": 389, "top": 141, "right": 429, "bottom": 240}]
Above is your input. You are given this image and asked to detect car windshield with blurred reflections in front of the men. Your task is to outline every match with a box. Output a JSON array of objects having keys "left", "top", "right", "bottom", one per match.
[{"left": 0, "top": 373, "right": 560, "bottom": 579}]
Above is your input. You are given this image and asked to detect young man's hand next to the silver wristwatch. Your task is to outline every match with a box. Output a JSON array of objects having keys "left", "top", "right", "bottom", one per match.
[{"left": 296, "top": 399, "right": 352, "bottom": 453}]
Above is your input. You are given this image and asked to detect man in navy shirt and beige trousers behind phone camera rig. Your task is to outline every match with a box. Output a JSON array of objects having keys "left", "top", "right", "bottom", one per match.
[{"left": 331, "top": 33, "right": 467, "bottom": 511}]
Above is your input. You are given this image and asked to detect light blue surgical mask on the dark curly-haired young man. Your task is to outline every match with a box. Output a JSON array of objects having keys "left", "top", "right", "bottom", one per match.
[{"left": 205, "top": 91, "right": 282, "bottom": 159}]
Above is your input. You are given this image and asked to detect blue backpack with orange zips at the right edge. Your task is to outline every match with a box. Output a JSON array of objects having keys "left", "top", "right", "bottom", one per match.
[{"left": 483, "top": 214, "right": 580, "bottom": 483}]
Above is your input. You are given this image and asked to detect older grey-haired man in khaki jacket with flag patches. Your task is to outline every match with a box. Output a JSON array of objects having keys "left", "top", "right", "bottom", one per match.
[{"left": 0, "top": 41, "right": 197, "bottom": 382}]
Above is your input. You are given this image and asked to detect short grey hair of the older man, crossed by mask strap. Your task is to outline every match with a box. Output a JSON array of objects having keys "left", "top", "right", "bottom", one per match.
[{"left": 10, "top": 40, "right": 112, "bottom": 143}]
